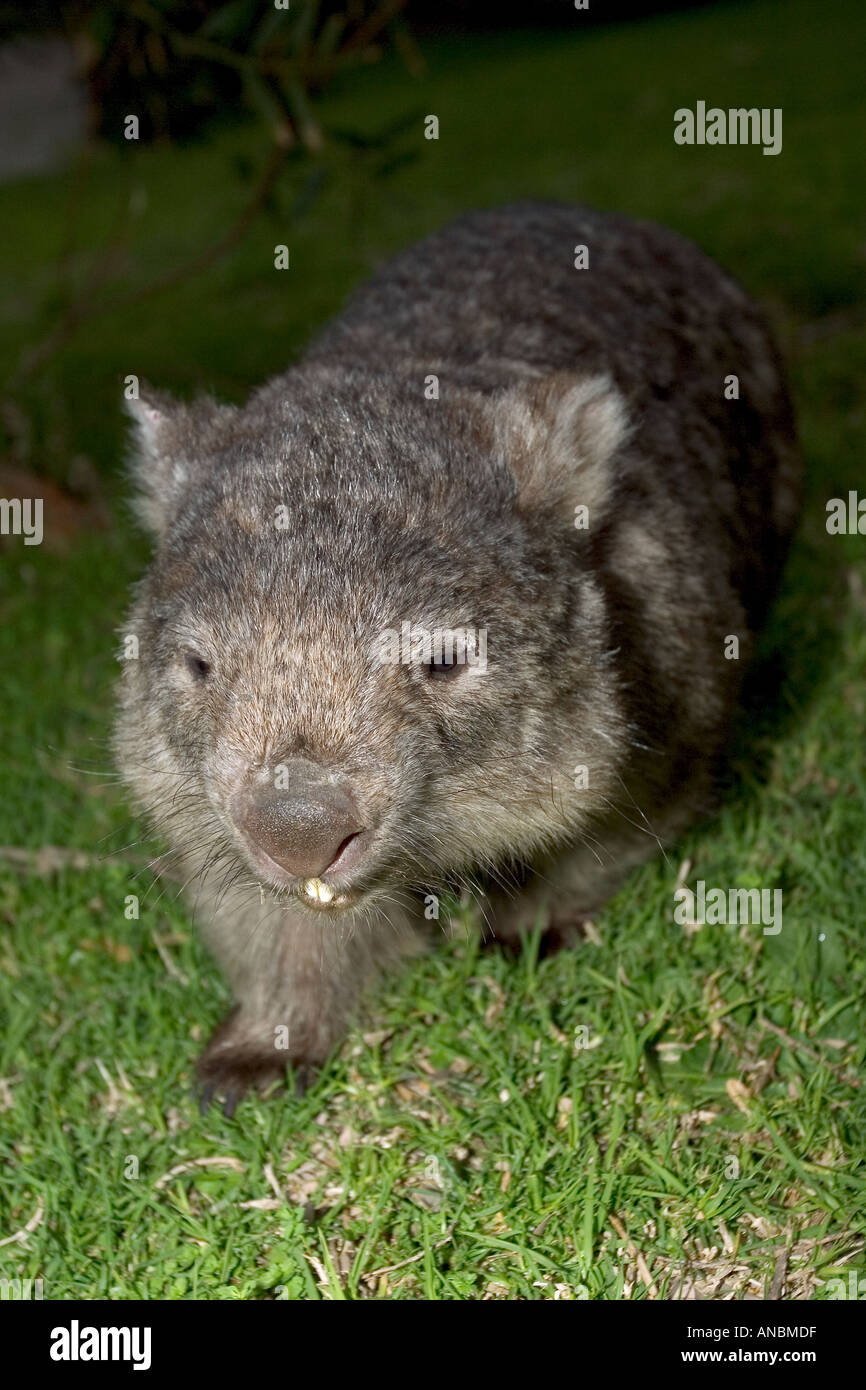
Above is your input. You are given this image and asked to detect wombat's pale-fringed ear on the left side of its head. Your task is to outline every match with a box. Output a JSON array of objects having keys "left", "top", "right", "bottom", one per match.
[{"left": 124, "top": 384, "right": 235, "bottom": 538}]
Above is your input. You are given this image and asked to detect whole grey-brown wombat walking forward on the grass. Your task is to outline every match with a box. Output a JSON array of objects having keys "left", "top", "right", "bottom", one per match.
[{"left": 117, "top": 203, "right": 799, "bottom": 1111}]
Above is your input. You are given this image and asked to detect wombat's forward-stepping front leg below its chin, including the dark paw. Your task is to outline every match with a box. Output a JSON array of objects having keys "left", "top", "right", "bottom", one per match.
[{"left": 197, "top": 899, "right": 417, "bottom": 1115}]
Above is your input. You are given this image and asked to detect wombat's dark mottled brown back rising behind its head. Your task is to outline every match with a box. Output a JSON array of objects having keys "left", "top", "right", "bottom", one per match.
[{"left": 306, "top": 203, "right": 799, "bottom": 623}]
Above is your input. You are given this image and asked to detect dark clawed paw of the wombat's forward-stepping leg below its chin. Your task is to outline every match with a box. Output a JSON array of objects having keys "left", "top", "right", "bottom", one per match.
[{"left": 196, "top": 1013, "right": 316, "bottom": 1119}]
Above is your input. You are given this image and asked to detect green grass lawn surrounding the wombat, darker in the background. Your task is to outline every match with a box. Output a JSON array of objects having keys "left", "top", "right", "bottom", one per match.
[{"left": 0, "top": 0, "right": 866, "bottom": 1300}]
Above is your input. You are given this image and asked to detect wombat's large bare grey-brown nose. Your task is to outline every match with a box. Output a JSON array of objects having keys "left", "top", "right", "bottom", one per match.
[{"left": 238, "top": 758, "right": 363, "bottom": 878}]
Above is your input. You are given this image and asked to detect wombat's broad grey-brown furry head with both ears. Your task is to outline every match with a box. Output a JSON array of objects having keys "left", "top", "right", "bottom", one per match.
[{"left": 117, "top": 370, "right": 626, "bottom": 912}]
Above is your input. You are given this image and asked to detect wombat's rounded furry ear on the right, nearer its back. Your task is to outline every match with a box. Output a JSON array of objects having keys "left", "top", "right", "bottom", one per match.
[{"left": 496, "top": 371, "right": 631, "bottom": 518}]
